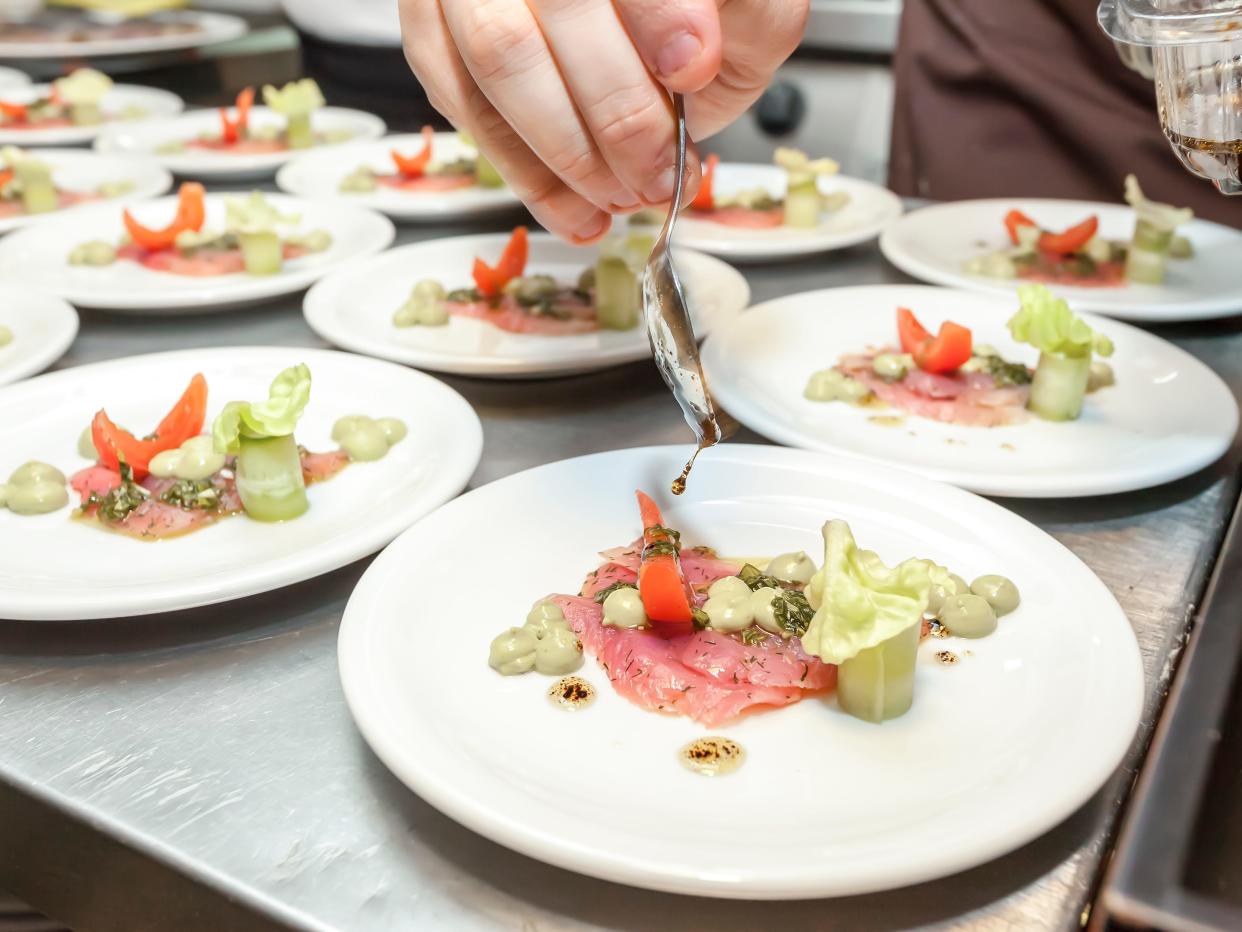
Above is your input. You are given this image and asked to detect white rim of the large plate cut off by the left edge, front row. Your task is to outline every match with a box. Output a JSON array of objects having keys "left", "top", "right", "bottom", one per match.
[{"left": 0, "top": 344, "right": 483, "bottom": 623}]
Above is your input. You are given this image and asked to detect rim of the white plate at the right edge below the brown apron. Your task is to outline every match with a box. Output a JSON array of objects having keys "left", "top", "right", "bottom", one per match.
[{"left": 879, "top": 198, "right": 1242, "bottom": 323}]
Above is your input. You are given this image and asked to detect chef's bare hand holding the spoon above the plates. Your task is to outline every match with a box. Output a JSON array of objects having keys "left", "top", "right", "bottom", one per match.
[{"left": 399, "top": 0, "right": 809, "bottom": 242}]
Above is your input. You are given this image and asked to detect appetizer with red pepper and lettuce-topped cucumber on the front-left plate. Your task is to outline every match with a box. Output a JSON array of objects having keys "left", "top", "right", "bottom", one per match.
[{"left": 0, "top": 364, "right": 406, "bottom": 541}]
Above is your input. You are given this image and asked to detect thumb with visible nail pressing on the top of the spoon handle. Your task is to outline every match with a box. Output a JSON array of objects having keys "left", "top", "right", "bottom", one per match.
[{"left": 616, "top": 0, "right": 720, "bottom": 93}]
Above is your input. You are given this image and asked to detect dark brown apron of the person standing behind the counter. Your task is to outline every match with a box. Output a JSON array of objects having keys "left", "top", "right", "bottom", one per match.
[{"left": 889, "top": 0, "right": 1242, "bottom": 226}]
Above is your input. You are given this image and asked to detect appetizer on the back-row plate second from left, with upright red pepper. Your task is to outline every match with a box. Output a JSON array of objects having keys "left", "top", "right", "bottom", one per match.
[{"left": 155, "top": 78, "right": 353, "bottom": 155}]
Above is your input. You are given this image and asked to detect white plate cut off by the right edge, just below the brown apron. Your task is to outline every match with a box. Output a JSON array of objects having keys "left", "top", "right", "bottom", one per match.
[{"left": 879, "top": 198, "right": 1242, "bottom": 321}]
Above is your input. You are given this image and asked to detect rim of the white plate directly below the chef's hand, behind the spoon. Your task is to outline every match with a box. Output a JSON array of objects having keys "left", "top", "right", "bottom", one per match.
[{"left": 302, "top": 231, "right": 750, "bottom": 379}]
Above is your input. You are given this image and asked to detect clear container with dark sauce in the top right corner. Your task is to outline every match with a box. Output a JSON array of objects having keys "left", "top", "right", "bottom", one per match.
[{"left": 1099, "top": 0, "right": 1242, "bottom": 194}]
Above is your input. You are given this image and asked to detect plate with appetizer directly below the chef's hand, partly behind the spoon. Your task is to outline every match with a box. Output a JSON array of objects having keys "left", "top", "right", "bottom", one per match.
[{"left": 303, "top": 232, "right": 750, "bottom": 378}]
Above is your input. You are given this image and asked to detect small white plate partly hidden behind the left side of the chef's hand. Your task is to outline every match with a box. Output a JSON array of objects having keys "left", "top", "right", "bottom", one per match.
[{"left": 276, "top": 133, "right": 522, "bottom": 220}]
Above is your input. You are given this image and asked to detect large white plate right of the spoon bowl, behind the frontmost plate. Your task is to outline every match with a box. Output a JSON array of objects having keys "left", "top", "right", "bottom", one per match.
[{"left": 703, "top": 285, "right": 1238, "bottom": 497}]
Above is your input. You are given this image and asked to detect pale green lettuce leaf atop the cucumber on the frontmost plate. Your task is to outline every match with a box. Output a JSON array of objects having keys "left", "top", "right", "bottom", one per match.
[{"left": 802, "top": 519, "right": 934, "bottom": 664}]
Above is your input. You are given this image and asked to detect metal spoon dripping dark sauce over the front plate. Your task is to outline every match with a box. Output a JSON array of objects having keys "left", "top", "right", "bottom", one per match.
[{"left": 642, "top": 94, "right": 720, "bottom": 495}]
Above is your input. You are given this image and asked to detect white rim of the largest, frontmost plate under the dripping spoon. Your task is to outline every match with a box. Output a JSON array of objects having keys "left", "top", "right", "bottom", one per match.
[{"left": 337, "top": 444, "right": 1146, "bottom": 900}]
